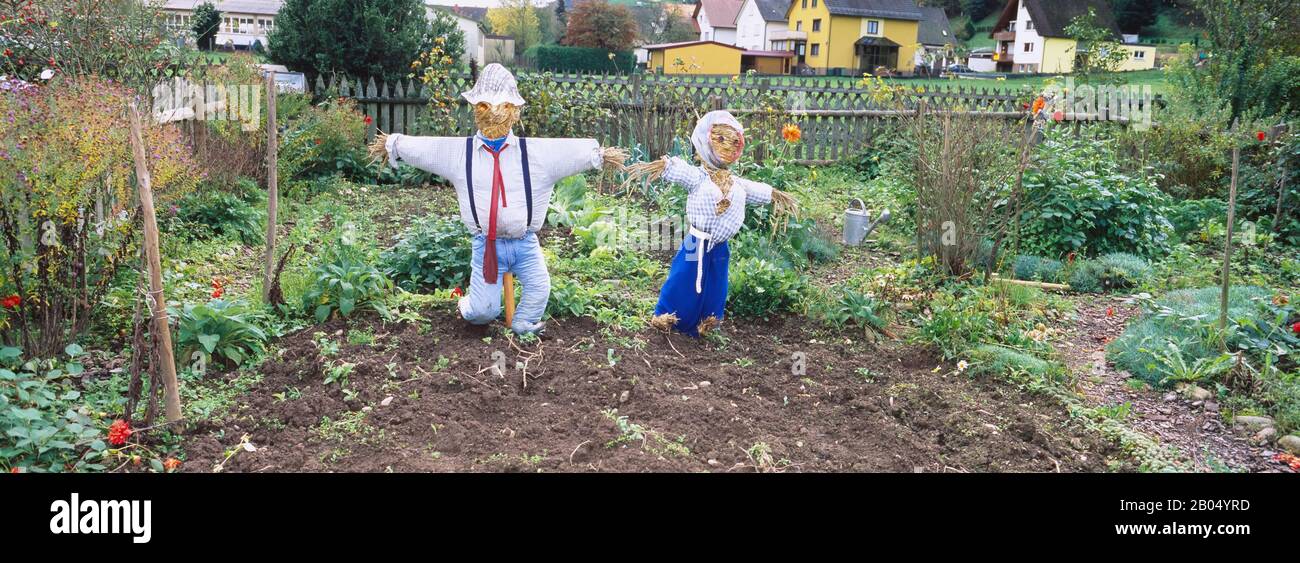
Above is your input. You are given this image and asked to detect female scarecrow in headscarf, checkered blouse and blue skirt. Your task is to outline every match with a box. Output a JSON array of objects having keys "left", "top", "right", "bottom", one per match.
[{"left": 628, "top": 112, "right": 797, "bottom": 337}]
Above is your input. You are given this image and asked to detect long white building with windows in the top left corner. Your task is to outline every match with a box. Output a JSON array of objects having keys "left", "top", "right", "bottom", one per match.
[{"left": 163, "top": 0, "right": 283, "bottom": 48}]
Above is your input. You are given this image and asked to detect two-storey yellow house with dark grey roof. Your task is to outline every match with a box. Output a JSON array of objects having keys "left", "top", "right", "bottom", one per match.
[{"left": 787, "top": 0, "right": 923, "bottom": 74}]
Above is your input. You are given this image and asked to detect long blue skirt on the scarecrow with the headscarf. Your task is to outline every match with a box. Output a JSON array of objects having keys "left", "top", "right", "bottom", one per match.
[{"left": 654, "top": 234, "right": 731, "bottom": 338}]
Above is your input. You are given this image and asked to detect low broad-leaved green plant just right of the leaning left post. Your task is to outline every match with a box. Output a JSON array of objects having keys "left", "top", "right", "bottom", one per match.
[{"left": 172, "top": 299, "right": 268, "bottom": 365}]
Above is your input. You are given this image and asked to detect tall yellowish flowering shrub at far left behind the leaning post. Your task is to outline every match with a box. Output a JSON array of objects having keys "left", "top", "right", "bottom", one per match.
[{"left": 0, "top": 78, "right": 203, "bottom": 358}]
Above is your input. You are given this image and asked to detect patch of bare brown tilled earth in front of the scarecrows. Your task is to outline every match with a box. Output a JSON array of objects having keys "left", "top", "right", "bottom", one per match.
[{"left": 185, "top": 304, "right": 1125, "bottom": 472}]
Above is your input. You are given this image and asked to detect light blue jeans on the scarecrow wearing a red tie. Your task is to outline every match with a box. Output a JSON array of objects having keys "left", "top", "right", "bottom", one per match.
[{"left": 460, "top": 233, "right": 551, "bottom": 334}]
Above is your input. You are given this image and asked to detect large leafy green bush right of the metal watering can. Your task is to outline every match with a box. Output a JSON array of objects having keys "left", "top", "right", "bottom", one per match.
[{"left": 1021, "top": 130, "right": 1173, "bottom": 256}]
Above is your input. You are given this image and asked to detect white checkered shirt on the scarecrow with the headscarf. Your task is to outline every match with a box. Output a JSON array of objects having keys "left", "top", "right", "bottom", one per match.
[{"left": 663, "top": 156, "right": 772, "bottom": 244}]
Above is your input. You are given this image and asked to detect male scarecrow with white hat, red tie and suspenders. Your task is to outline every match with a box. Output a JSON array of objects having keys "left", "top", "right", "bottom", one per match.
[{"left": 371, "top": 62, "right": 627, "bottom": 334}]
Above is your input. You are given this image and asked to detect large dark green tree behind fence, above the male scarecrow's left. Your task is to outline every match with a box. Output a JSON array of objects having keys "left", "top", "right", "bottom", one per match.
[{"left": 270, "top": 0, "right": 429, "bottom": 79}]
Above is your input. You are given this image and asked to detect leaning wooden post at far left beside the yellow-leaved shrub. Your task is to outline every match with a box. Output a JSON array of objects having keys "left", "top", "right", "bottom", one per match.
[{"left": 130, "top": 101, "right": 181, "bottom": 423}]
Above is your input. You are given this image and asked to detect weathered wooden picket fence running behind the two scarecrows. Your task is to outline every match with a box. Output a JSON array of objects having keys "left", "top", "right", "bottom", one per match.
[{"left": 309, "top": 74, "right": 1152, "bottom": 163}]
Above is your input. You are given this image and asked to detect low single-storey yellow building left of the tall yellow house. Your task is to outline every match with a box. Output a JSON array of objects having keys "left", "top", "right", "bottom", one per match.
[{"left": 642, "top": 42, "right": 793, "bottom": 75}]
